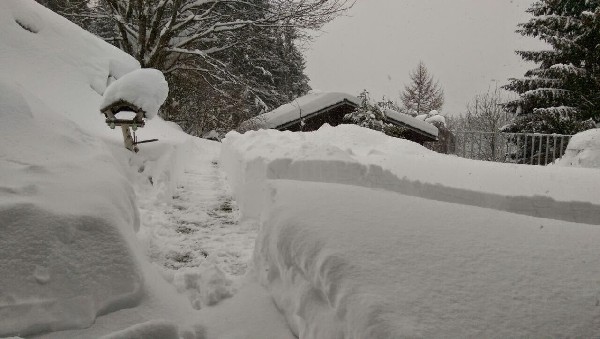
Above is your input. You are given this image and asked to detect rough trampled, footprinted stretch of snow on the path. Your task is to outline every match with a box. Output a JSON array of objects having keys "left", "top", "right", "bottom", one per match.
[{"left": 137, "top": 143, "right": 257, "bottom": 309}]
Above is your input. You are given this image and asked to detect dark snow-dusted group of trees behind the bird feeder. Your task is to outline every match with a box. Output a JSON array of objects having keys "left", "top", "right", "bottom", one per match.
[{"left": 37, "top": 0, "right": 353, "bottom": 135}]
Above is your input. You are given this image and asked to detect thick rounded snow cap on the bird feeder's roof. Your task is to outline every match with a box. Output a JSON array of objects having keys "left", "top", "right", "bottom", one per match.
[{"left": 100, "top": 68, "right": 169, "bottom": 119}]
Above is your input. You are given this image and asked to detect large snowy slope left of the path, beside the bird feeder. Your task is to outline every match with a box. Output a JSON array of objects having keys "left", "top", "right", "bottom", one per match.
[{"left": 0, "top": 0, "right": 202, "bottom": 338}]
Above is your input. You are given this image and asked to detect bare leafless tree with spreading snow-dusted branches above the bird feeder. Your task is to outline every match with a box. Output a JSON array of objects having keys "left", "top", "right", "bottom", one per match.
[{"left": 96, "top": 0, "right": 353, "bottom": 78}]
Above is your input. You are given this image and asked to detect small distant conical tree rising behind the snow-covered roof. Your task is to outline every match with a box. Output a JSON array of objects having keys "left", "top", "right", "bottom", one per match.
[{"left": 400, "top": 61, "right": 444, "bottom": 115}]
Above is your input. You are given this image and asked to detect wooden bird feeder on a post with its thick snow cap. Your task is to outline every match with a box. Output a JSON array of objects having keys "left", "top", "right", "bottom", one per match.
[{"left": 100, "top": 68, "right": 169, "bottom": 152}]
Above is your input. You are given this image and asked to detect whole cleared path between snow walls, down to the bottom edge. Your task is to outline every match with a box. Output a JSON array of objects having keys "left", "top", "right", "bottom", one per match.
[{"left": 137, "top": 141, "right": 295, "bottom": 339}]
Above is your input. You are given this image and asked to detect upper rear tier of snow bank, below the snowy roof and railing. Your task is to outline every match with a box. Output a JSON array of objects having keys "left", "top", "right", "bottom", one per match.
[{"left": 222, "top": 125, "right": 600, "bottom": 224}]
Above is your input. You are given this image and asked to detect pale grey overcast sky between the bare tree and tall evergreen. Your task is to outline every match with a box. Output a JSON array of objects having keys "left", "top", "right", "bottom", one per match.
[{"left": 306, "top": 0, "right": 543, "bottom": 114}]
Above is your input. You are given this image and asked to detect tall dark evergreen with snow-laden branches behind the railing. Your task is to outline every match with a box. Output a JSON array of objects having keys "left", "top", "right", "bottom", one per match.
[{"left": 504, "top": 0, "right": 600, "bottom": 134}]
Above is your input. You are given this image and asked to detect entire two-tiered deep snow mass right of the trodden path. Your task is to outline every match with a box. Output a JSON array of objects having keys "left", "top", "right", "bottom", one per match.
[{"left": 221, "top": 125, "right": 600, "bottom": 338}]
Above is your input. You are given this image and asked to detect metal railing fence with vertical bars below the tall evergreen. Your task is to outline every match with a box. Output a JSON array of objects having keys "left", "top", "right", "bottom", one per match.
[{"left": 453, "top": 131, "right": 571, "bottom": 165}]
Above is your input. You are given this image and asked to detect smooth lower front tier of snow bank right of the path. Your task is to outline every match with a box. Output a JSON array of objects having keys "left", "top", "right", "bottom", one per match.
[{"left": 255, "top": 180, "right": 600, "bottom": 338}]
